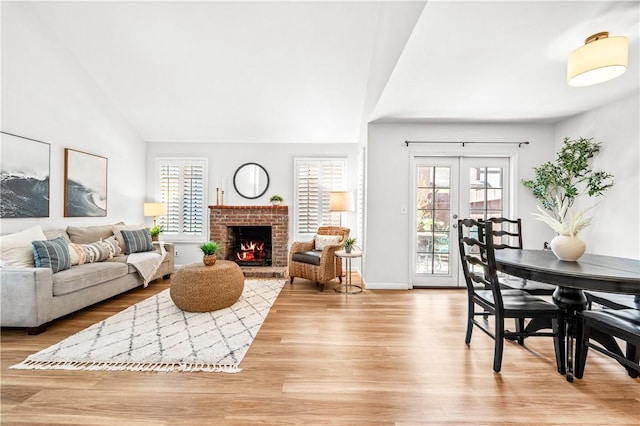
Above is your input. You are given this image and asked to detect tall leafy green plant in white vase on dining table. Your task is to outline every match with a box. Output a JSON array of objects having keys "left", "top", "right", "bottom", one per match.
[{"left": 522, "top": 137, "right": 613, "bottom": 260}]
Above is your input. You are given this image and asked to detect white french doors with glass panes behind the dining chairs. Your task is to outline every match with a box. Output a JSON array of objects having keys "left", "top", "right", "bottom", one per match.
[{"left": 410, "top": 156, "right": 510, "bottom": 288}]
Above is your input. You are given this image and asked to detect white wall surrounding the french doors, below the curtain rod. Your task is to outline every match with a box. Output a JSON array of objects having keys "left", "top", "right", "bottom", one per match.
[{"left": 364, "top": 123, "right": 554, "bottom": 289}]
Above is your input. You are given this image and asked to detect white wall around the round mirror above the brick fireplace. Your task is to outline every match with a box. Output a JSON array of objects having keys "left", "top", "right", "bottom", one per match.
[{"left": 146, "top": 141, "right": 361, "bottom": 265}]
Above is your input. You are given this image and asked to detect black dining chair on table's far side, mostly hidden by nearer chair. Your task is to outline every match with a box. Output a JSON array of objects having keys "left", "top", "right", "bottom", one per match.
[{"left": 480, "top": 217, "right": 556, "bottom": 296}]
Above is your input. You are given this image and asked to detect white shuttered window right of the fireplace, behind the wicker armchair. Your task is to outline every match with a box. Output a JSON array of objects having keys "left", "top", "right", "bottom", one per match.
[{"left": 295, "top": 158, "right": 347, "bottom": 234}]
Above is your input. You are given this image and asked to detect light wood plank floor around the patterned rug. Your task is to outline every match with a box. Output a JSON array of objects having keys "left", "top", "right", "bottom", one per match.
[{"left": 0, "top": 279, "right": 640, "bottom": 425}]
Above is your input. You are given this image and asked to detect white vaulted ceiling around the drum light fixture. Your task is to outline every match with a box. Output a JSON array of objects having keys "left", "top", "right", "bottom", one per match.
[{"left": 25, "top": 1, "right": 640, "bottom": 143}]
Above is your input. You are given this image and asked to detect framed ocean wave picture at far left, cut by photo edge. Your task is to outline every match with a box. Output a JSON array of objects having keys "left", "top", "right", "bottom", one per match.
[{"left": 0, "top": 132, "right": 51, "bottom": 218}]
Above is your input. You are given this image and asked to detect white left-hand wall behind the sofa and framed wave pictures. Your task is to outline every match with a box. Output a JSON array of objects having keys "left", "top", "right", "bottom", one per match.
[{"left": 0, "top": 2, "right": 145, "bottom": 234}]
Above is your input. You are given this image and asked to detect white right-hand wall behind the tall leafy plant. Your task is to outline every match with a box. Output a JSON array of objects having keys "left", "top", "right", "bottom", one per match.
[{"left": 554, "top": 93, "right": 640, "bottom": 259}]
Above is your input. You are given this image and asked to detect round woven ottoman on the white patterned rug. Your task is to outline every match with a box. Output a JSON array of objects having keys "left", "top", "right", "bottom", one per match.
[{"left": 169, "top": 260, "right": 244, "bottom": 312}]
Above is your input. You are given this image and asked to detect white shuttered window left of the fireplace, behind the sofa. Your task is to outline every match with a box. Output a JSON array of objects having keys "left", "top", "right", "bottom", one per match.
[{"left": 158, "top": 159, "right": 207, "bottom": 241}]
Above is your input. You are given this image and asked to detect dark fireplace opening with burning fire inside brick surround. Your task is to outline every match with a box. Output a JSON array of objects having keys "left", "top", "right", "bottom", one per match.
[{"left": 227, "top": 226, "right": 271, "bottom": 266}]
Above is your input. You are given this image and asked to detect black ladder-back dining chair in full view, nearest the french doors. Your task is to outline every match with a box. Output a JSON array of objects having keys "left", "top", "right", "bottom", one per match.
[{"left": 458, "top": 219, "right": 566, "bottom": 374}]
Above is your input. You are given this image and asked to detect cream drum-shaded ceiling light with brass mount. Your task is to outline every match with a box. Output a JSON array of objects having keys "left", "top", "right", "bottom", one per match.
[{"left": 567, "top": 32, "right": 629, "bottom": 87}]
